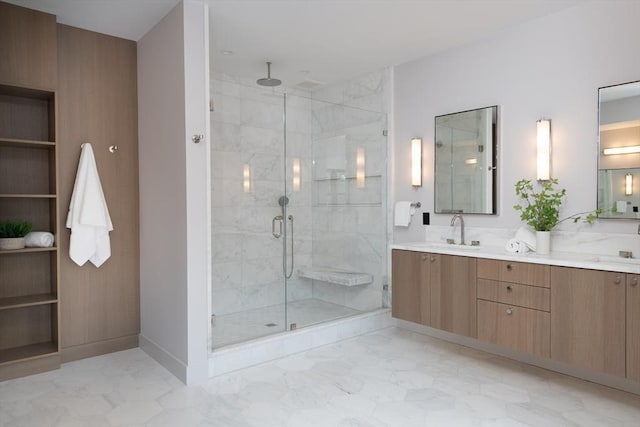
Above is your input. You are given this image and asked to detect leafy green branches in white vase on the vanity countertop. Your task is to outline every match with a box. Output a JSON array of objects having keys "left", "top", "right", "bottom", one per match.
[{"left": 513, "top": 179, "right": 600, "bottom": 254}]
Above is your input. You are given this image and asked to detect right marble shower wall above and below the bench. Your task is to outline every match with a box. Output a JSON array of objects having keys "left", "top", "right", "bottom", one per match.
[{"left": 312, "top": 70, "right": 389, "bottom": 311}]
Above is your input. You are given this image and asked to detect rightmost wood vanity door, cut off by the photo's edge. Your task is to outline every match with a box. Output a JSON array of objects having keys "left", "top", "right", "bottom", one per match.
[{"left": 627, "top": 274, "right": 640, "bottom": 381}]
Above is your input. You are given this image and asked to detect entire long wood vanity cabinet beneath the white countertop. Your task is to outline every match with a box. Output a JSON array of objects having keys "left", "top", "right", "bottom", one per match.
[{"left": 392, "top": 249, "right": 640, "bottom": 393}]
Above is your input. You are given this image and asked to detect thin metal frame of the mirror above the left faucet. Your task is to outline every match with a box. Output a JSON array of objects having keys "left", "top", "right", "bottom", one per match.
[{"left": 433, "top": 105, "right": 500, "bottom": 215}]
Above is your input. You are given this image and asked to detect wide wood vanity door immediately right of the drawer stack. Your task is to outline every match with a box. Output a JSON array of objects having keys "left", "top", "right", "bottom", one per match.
[{"left": 551, "top": 267, "right": 626, "bottom": 377}]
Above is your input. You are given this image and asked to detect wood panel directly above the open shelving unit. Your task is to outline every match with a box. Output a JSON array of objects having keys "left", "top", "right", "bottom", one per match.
[{"left": 0, "top": 2, "right": 58, "bottom": 90}]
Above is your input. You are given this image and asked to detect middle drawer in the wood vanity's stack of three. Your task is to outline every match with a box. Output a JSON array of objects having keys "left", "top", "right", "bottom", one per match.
[{"left": 478, "top": 279, "right": 550, "bottom": 311}]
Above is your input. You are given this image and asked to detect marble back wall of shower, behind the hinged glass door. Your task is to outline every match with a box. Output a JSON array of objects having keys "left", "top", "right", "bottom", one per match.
[{"left": 211, "top": 74, "right": 312, "bottom": 320}]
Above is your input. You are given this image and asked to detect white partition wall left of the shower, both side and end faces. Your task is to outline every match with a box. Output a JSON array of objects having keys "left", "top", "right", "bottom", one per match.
[{"left": 138, "top": 1, "right": 207, "bottom": 382}]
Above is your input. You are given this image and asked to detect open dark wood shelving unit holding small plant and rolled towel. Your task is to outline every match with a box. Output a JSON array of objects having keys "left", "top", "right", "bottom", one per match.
[{"left": 0, "top": 84, "right": 60, "bottom": 380}]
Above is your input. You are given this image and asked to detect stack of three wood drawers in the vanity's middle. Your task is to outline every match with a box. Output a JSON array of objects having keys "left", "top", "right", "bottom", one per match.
[{"left": 477, "top": 259, "right": 551, "bottom": 357}]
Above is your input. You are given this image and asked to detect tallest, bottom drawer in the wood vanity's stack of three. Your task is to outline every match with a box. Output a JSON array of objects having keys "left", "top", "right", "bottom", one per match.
[{"left": 478, "top": 300, "right": 550, "bottom": 357}]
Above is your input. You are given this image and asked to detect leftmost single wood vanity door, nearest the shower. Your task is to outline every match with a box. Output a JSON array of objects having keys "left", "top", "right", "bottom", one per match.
[{"left": 391, "top": 249, "right": 432, "bottom": 325}]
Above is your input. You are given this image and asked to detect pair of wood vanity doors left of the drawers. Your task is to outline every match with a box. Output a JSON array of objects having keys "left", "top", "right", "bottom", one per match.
[{"left": 392, "top": 250, "right": 476, "bottom": 337}]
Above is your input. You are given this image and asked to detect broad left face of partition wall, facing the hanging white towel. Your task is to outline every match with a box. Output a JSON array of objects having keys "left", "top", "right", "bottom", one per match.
[{"left": 138, "top": 0, "right": 187, "bottom": 372}]
